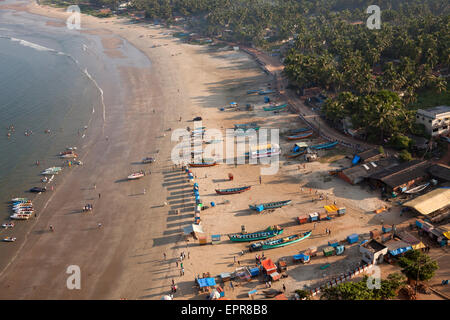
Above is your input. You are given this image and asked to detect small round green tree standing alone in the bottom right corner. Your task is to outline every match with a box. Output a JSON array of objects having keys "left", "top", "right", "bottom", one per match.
[{"left": 398, "top": 250, "right": 439, "bottom": 281}]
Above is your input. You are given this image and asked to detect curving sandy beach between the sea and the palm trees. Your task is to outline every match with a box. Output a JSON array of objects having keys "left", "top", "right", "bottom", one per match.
[{"left": 0, "top": 3, "right": 446, "bottom": 299}]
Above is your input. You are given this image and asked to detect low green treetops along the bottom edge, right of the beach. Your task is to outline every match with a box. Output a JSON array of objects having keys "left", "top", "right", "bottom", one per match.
[{"left": 321, "top": 273, "right": 405, "bottom": 300}]
